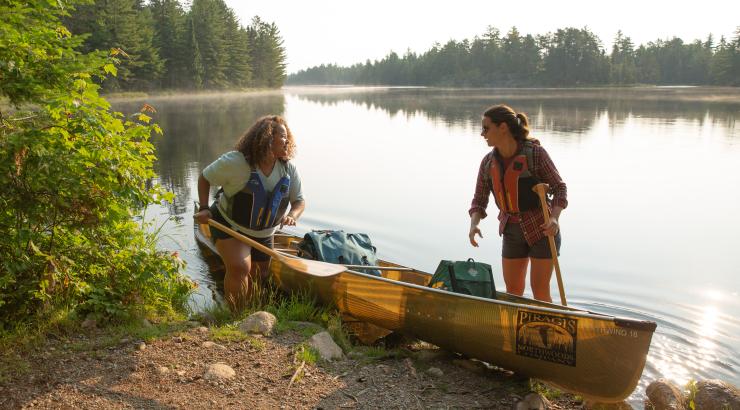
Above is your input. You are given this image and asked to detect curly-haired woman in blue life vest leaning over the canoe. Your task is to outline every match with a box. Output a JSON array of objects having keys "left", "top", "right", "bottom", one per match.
[{"left": 195, "top": 115, "right": 306, "bottom": 309}]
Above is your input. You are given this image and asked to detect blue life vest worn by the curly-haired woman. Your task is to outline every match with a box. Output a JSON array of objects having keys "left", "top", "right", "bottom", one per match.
[{"left": 218, "top": 170, "right": 290, "bottom": 231}]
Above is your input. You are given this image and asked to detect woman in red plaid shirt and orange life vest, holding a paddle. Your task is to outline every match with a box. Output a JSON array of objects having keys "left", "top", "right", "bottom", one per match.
[{"left": 468, "top": 105, "right": 568, "bottom": 302}]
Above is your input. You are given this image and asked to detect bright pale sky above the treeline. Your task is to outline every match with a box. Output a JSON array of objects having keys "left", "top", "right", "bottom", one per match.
[{"left": 226, "top": 0, "right": 740, "bottom": 73}]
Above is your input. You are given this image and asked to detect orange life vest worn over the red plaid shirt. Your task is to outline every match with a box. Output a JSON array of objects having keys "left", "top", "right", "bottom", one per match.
[{"left": 489, "top": 141, "right": 540, "bottom": 214}]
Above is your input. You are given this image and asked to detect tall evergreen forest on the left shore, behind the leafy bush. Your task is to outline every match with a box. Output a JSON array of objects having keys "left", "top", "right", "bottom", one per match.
[{"left": 63, "top": 0, "right": 286, "bottom": 91}]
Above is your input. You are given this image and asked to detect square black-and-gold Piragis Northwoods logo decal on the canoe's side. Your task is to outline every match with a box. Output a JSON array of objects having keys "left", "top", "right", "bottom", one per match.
[{"left": 516, "top": 310, "right": 578, "bottom": 366}]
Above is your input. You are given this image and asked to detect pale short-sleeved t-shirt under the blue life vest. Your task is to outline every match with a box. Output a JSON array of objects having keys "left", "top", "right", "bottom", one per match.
[{"left": 203, "top": 151, "right": 303, "bottom": 238}]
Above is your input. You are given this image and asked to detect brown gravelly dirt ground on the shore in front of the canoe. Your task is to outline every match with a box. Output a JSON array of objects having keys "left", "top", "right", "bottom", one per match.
[{"left": 0, "top": 324, "right": 582, "bottom": 409}]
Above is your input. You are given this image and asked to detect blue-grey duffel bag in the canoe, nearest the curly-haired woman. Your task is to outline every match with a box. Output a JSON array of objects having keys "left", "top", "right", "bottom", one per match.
[{"left": 298, "top": 230, "right": 381, "bottom": 276}]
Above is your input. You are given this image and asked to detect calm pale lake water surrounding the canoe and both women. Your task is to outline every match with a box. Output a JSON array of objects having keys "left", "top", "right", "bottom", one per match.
[{"left": 114, "top": 88, "right": 740, "bottom": 405}]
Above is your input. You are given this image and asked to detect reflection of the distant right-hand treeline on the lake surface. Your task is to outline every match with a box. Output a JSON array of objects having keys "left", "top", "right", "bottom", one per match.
[{"left": 287, "top": 88, "right": 740, "bottom": 136}]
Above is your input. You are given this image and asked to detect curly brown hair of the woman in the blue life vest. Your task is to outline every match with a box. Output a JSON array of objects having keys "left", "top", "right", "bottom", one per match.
[{"left": 234, "top": 115, "right": 295, "bottom": 168}]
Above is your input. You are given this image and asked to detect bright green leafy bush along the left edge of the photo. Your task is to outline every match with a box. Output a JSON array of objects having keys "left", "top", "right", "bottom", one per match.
[{"left": 0, "top": 0, "right": 191, "bottom": 328}]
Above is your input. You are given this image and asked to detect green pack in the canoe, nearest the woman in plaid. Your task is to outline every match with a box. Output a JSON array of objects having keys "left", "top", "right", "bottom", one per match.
[{"left": 429, "top": 258, "right": 496, "bottom": 299}]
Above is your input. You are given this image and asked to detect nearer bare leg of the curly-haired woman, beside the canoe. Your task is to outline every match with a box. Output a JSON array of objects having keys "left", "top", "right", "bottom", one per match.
[{"left": 216, "top": 238, "right": 252, "bottom": 311}]
